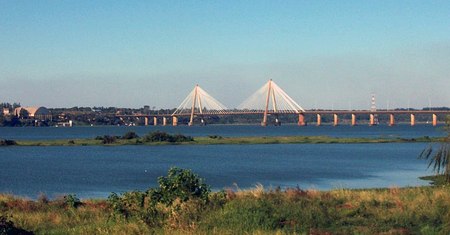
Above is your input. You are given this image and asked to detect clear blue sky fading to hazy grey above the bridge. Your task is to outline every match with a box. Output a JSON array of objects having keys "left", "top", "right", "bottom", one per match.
[{"left": 0, "top": 0, "right": 450, "bottom": 109}]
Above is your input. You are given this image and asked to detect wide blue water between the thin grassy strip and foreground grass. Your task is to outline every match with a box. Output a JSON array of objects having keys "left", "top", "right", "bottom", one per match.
[{"left": 0, "top": 143, "right": 430, "bottom": 198}]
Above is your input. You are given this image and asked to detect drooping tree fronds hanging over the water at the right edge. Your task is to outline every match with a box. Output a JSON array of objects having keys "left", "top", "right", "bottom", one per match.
[{"left": 419, "top": 116, "right": 450, "bottom": 183}]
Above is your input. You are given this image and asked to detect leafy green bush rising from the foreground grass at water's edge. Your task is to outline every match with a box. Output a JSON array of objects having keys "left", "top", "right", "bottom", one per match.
[{"left": 108, "top": 167, "right": 209, "bottom": 229}]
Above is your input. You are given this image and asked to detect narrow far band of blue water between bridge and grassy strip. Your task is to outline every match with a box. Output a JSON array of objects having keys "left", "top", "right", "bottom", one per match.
[{"left": 0, "top": 125, "right": 444, "bottom": 140}]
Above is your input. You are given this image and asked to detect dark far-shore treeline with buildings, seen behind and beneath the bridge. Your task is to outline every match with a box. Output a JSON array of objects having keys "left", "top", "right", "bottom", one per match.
[{"left": 0, "top": 103, "right": 450, "bottom": 127}]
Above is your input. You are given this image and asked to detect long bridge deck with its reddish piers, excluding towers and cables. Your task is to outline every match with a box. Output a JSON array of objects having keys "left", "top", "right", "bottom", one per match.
[{"left": 115, "top": 110, "right": 450, "bottom": 126}]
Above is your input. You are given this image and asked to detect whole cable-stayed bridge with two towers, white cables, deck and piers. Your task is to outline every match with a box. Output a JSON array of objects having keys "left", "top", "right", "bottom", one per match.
[{"left": 116, "top": 80, "right": 450, "bottom": 126}]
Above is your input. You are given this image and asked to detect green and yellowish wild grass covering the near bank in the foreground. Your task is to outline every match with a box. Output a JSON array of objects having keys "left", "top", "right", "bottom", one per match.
[{"left": 0, "top": 186, "right": 450, "bottom": 234}]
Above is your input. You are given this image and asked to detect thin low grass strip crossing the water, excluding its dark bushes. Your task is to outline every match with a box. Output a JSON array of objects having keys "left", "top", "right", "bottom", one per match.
[{"left": 10, "top": 136, "right": 441, "bottom": 146}]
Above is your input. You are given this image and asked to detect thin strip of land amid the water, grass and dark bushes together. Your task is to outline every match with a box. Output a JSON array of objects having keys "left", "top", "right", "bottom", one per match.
[{"left": 0, "top": 131, "right": 444, "bottom": 146}]
